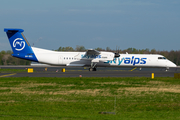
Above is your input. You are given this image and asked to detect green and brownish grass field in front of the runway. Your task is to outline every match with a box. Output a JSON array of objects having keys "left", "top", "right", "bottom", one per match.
[{"left": 0, "top": 77, "right": 180, "bottom": 120}]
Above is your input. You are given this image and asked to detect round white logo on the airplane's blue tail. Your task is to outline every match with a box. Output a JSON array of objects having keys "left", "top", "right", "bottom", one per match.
[{"left": 13, "top": 38, "right": 25, "bottom": 51}]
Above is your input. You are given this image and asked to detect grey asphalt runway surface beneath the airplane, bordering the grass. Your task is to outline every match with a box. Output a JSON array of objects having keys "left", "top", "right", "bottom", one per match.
[{"left": 0, "top": 66, "right": 180, "bottom": 77}]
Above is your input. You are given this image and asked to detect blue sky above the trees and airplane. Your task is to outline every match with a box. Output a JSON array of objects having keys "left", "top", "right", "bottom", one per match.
[{"left": 0, "top": 0, "right": 180, "bottom": 51}]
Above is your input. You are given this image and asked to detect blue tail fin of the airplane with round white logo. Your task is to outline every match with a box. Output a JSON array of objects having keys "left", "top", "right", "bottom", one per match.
[{"left": 4, "top": 28, "right": 37, "bottom": 62}]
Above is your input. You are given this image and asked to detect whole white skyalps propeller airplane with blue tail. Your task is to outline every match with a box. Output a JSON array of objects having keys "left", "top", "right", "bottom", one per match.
[{"left": 4, "top": 28, "right": 176, "bottom": 71}]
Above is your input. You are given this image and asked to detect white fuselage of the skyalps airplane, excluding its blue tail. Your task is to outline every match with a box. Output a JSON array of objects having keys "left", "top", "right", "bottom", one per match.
[{"left": 32, "top": 47, "right": 176, "bottom": 67}]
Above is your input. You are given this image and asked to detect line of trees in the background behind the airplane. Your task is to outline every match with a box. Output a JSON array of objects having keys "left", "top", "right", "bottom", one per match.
[{"left": 0, "top": 45, "right": 180, "bottom": 65}]
